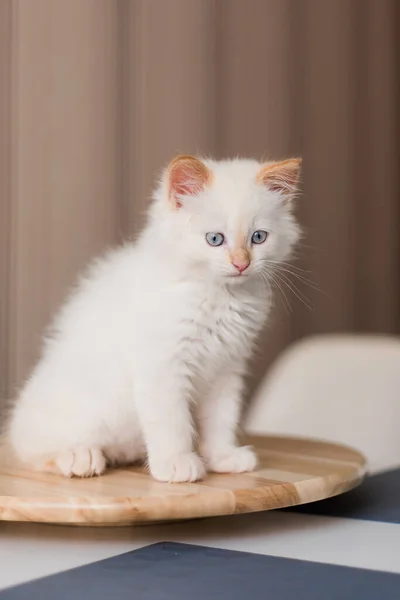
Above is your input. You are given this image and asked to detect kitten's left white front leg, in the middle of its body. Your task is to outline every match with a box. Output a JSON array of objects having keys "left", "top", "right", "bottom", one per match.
[{"left": 136, "top": 371, "right": 205, "bottom": 483}]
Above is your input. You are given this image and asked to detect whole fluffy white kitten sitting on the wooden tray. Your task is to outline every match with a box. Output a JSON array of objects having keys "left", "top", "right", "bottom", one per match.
[{"left": 9, "top": 156, "right": 300, "bottom": 482}]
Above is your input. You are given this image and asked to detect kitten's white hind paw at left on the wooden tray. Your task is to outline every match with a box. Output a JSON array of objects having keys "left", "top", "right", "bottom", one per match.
[{"left": 48, "top": 448, "right": 106, "bottom": 477}]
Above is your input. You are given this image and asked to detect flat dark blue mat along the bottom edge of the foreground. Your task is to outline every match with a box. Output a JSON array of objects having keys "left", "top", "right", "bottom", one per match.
[{"left": 0, "top": 540, "right": 400, "bottom": 600}]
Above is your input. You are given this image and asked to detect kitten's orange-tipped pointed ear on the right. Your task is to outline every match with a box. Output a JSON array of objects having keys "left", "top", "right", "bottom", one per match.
[{"left": 257, "top": 158, "right": 301, "bottom": 199}]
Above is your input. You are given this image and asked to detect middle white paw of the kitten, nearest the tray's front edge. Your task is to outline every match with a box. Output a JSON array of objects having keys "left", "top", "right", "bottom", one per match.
[{"left": 149, "top": 452, "right": 206, "bottom": 483}]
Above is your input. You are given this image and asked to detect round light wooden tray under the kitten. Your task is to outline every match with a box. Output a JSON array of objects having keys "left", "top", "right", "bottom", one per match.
[{"left": 0, "top": 437, "right": 365, "bottom": 526}]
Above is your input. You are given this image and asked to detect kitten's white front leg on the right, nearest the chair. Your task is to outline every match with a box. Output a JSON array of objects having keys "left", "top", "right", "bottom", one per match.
[{"left": 198, "top": 370, "right": 257, "bottom": 473}]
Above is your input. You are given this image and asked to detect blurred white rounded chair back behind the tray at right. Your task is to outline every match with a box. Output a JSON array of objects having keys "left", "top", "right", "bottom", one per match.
[{"left": 245, "top": 335, "right": 400, "bottom": 472}]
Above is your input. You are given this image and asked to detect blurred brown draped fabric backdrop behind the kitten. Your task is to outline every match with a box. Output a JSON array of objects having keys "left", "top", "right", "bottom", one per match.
[{"left": 0, "top": 0, "right": 400, "bottom": 410}]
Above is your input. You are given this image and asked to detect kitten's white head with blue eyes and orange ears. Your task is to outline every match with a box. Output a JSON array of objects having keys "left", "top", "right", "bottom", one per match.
[{"left": 153, "top": 156, "right": 301, "bottom": 283}]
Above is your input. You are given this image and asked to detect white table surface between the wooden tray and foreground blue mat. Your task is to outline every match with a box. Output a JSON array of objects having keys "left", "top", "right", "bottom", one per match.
[{"left": 0, "top": 511, "right": 400, "bottom": 589}]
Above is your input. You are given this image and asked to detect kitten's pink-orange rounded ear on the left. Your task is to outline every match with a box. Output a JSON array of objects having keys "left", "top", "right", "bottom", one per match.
[{"left": 168, "top": 156, "right": 212, "bottom": 208}]
